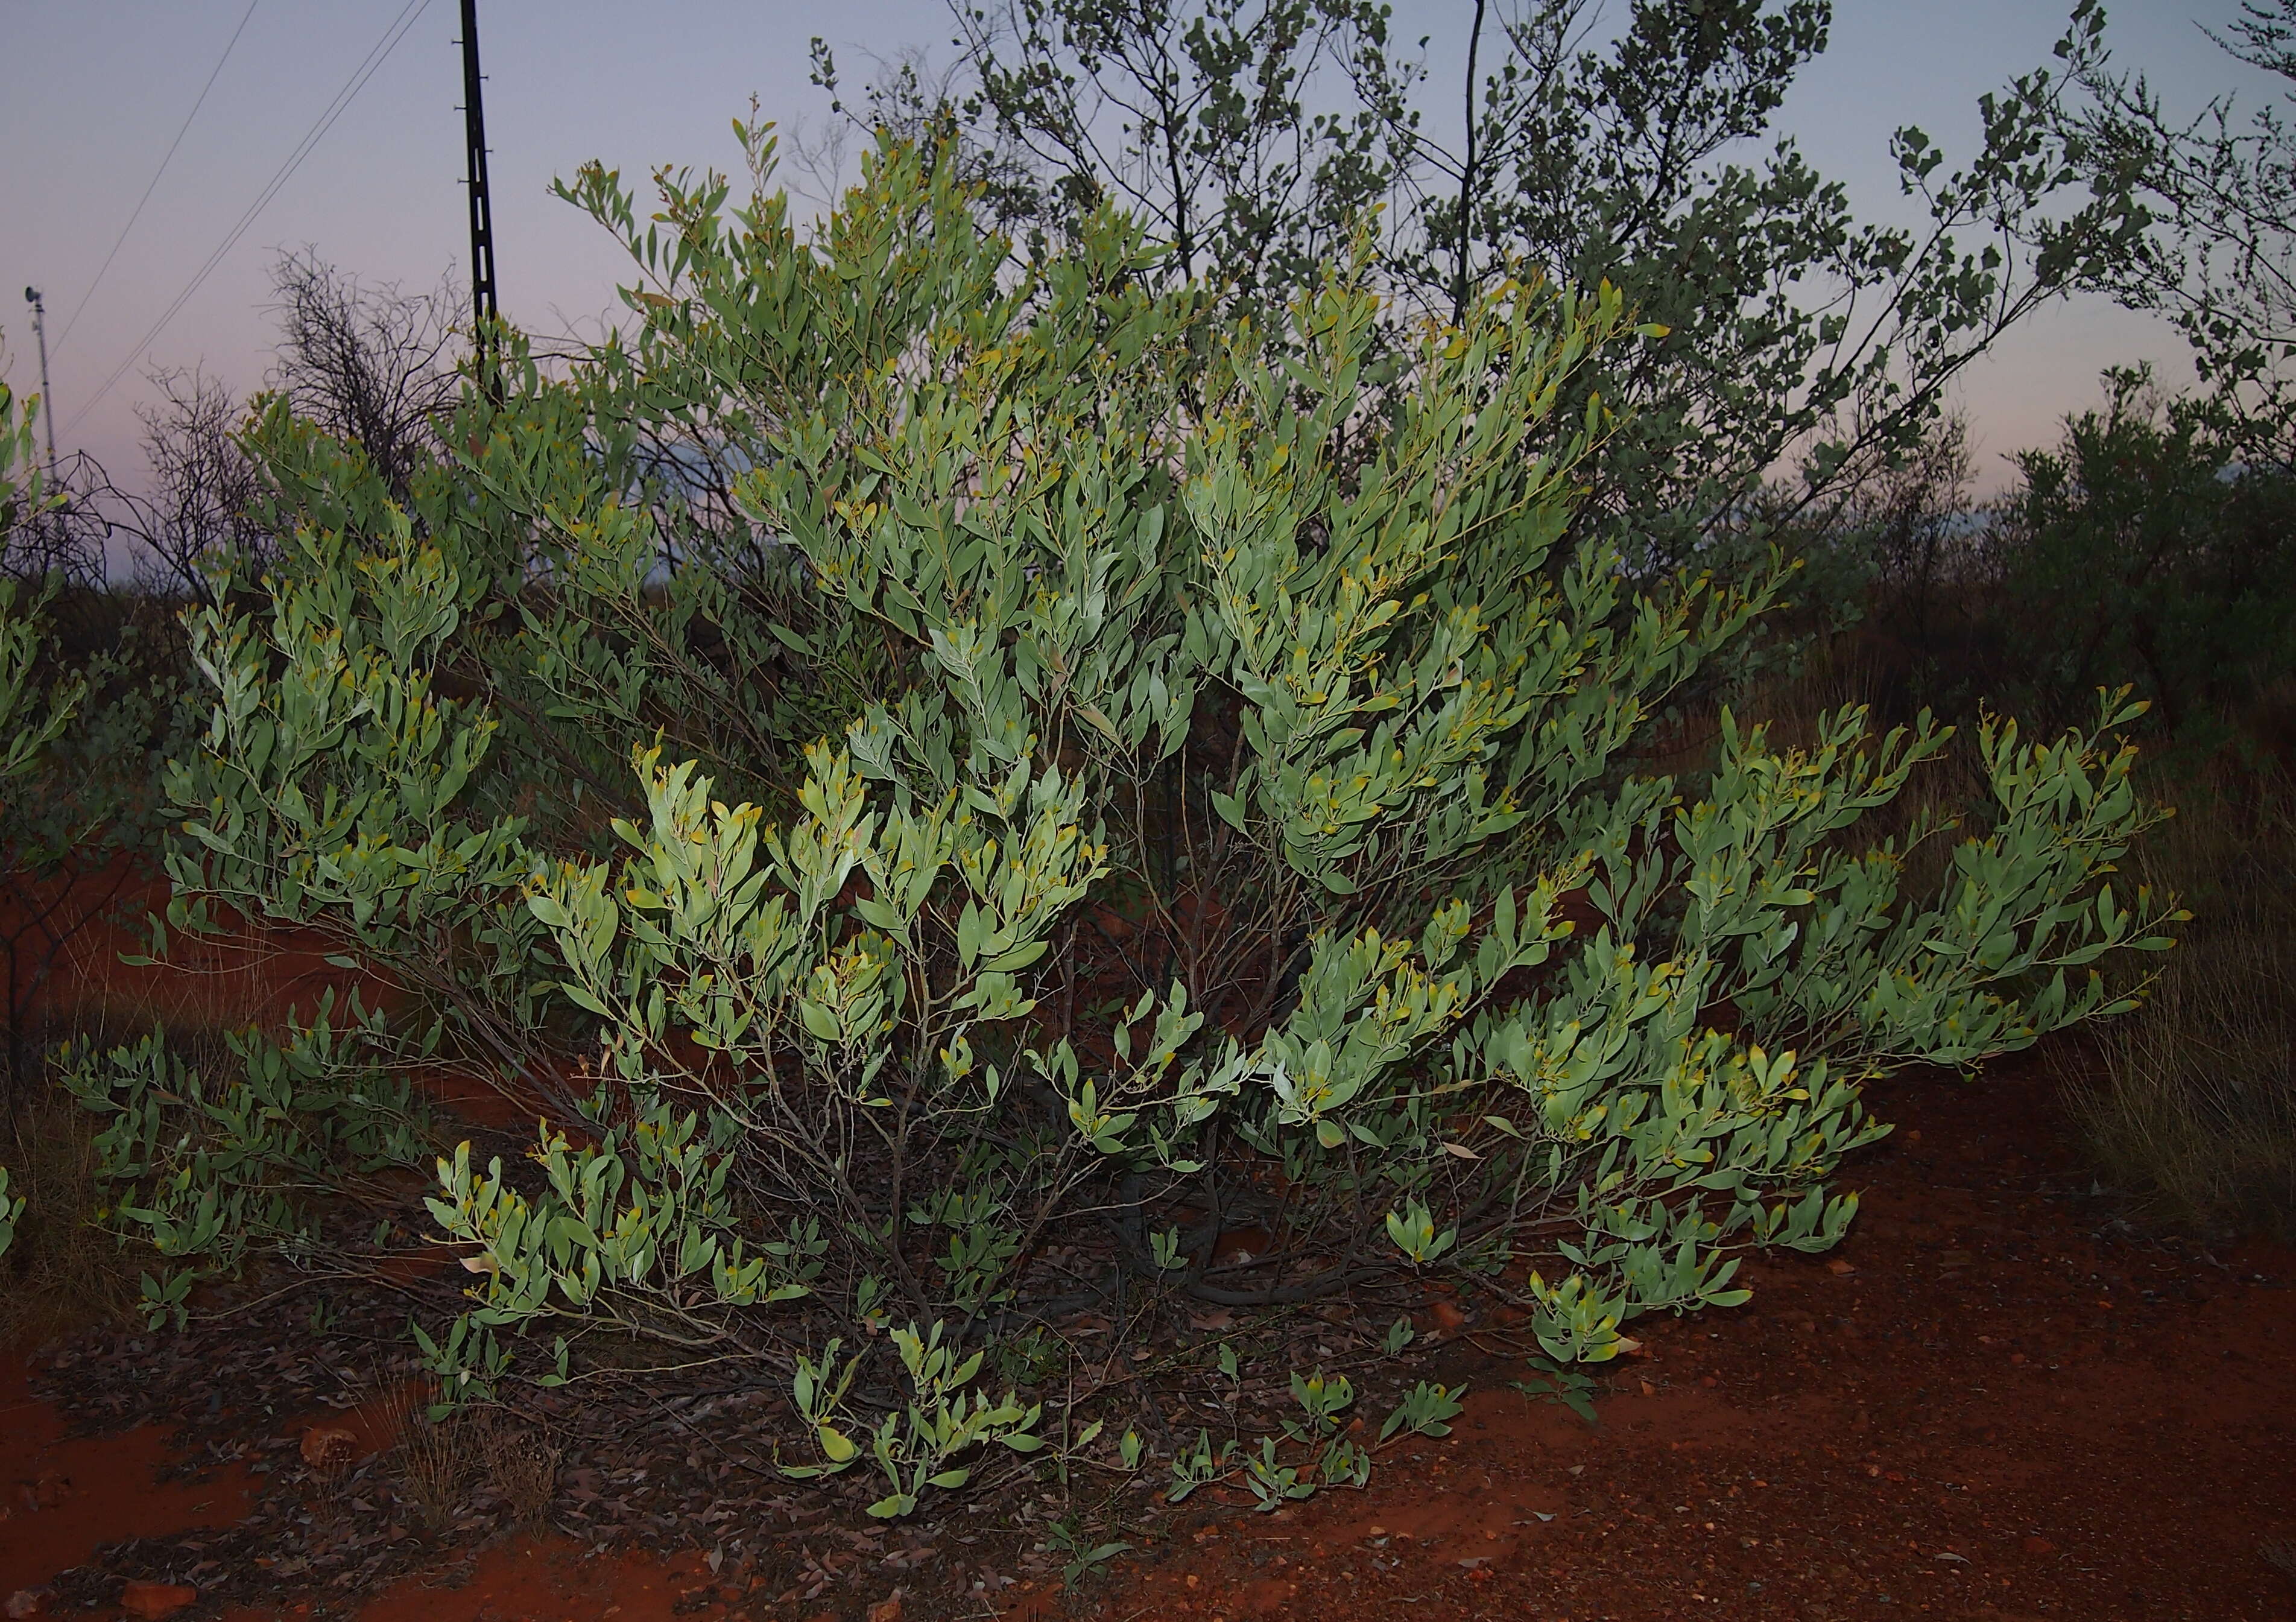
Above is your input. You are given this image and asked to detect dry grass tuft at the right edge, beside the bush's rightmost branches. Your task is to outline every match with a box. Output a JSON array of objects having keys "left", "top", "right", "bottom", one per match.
[{"left": 2060, "top": 772, "right": 2296, "bottom": 1238}]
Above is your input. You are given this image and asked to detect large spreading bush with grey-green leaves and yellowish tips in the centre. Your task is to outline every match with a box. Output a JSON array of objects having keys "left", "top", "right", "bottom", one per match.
[{"left": 71, "top": 131, "right": 2177, "bottom": 1514}]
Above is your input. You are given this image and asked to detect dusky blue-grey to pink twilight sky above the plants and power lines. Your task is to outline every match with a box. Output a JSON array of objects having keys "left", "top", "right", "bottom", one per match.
[{"left": 0, "top": 0, "right": 2273, "bottom": 489}]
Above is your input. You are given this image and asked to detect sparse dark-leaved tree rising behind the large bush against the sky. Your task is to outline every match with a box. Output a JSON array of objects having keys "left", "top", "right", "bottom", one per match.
[{"left": 950, "top": 0, "right": 2145, "bottom": 574}]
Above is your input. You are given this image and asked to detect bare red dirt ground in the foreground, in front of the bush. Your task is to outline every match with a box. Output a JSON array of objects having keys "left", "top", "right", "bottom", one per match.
[{"left": 0, "top": 1068, "right": 2296, "bottom": 1622}]
